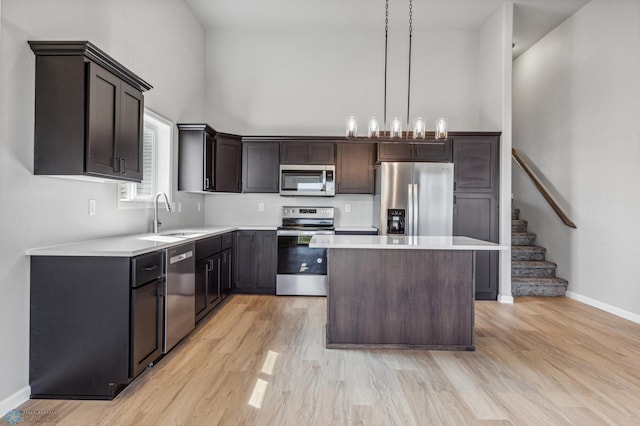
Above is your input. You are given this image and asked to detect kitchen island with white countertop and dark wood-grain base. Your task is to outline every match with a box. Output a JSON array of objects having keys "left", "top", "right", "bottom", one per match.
[{"left": 309, "top": 235, "right": 506, "bottom": 350}]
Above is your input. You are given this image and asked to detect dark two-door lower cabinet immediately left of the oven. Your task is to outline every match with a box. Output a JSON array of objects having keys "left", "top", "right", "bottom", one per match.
[{"left": 233, "top": 230, "right": 277, "bottom": 294}]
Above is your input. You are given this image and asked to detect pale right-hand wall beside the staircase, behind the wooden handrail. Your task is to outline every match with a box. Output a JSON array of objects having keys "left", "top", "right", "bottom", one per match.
[{"left": 513, "top": 0, "right": 640, "bottom": 322}]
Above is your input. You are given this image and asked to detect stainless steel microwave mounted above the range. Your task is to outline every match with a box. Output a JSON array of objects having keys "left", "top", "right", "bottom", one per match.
[{"left": 280, "top": 164, "right": 336, "bottom": 197}]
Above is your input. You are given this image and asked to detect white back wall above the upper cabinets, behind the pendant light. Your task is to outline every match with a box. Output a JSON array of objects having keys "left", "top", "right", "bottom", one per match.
[{"left": 207, "top": 23, "right": 480, "bottom": 136}]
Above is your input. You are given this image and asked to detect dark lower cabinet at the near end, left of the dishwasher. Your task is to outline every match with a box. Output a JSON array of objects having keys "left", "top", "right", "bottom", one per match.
[{"left": 29, "top": 252, "right": 164, "bottom": 399}]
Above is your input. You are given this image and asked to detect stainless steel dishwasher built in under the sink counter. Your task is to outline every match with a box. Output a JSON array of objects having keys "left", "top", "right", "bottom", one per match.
[{"left": 164, "top": 243, "right": 196, "bottom": 353}]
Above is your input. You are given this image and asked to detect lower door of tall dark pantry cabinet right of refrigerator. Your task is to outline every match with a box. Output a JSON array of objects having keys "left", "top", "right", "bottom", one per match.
[{"left": 453, "top": 193, "right": 499, "bottom": 300}]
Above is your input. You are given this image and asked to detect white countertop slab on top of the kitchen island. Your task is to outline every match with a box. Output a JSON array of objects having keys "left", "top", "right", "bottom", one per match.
[{"left": 309, "top": 235, "right": 507, "bottom": 250}]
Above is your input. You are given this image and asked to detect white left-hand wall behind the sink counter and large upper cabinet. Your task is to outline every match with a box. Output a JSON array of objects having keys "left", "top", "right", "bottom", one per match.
[{"left": 0, "top": 0, "right": 205, "bottom": 413}]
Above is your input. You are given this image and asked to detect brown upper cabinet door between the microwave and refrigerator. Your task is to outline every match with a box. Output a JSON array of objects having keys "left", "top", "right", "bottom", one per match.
[{"left": 336, "top": 143, "right": 376, "bottom": 194}]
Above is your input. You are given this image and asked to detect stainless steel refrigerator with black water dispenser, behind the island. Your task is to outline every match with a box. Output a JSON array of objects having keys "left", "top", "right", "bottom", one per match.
[{"left": 373, "top": 162, "right": 453, "bottom": 236}]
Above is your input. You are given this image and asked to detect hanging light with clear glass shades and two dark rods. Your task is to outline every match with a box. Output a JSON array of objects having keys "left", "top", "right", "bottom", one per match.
[{"left": 346, "top": 0, "right": 448, "bottom": 143}]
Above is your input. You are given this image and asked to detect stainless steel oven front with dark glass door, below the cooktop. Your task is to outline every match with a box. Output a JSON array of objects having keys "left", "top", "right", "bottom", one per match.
[{"left": 276, "top": 230, "right": 334, "bottom": 296}]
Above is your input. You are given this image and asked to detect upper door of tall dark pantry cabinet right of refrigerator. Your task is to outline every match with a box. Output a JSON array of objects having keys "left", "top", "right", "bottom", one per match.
[{"left": 453, "top": 136, "right": 499, "bottom": 193}]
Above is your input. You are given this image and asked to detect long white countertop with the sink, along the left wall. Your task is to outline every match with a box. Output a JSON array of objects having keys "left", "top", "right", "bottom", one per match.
[{"left": 26, "top": 225, "right": 276, "bottom": 257}]
